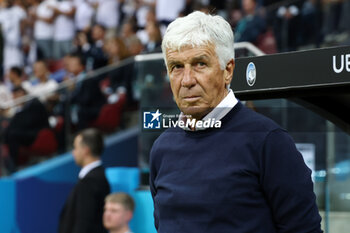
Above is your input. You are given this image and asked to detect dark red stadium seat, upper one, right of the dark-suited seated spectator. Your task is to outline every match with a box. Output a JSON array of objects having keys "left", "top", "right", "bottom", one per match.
[{"left": 90, "top": 93, "right": 126, "bottom": 133}]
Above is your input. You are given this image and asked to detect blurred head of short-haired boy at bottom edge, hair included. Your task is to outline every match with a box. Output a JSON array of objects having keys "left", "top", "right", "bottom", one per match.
[{"left": 103, "top": 193, "right": 135, "bottom": 233}]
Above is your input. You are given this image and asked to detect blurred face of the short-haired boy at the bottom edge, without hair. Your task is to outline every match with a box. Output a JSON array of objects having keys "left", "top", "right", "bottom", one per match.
[{"left": 103, "top": 202, "right": 132, "bottom": 231}]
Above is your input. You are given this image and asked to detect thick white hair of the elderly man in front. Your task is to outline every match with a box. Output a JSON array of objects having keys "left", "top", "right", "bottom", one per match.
[{"left": 162, "top": 11, "right": 235, "bottom": 70}]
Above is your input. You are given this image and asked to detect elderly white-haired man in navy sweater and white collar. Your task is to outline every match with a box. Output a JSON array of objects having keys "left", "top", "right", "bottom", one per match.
[{"left": 150, "top": 12, "right": 322, "bottom": 233}]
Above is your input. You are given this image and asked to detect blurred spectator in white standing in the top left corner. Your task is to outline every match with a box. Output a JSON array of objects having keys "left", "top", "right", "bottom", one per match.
[{"left": 0, "top": 0, "right": 27, "bottom": 73}]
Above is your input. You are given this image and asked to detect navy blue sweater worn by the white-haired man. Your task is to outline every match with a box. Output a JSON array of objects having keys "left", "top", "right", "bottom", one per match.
[{"left": 150, "top": 102, "right": 322, "bottom": 233}]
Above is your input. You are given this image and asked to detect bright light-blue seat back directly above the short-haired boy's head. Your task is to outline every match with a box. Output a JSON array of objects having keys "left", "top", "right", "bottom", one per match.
[{"left": 105, "top": 167, "right": 140, "bottom": 193}]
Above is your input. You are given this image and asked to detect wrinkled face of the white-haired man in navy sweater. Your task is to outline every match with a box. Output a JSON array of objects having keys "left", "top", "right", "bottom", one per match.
[{"left": 166, "top": 44, "right": 234, "bottom": 119}]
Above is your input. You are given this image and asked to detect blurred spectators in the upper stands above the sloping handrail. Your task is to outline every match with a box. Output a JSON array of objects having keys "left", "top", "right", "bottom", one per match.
[{"left": 0, "top": 0, "right": 350, "bottom": 91}]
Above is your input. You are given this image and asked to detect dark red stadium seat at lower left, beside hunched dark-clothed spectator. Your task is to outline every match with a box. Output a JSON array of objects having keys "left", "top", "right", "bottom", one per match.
[{"left": 18, "top": 128, "right": 58, "bottom": 165}]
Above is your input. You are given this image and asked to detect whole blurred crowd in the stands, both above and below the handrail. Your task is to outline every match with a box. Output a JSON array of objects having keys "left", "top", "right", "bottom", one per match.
[{"left": 0, "top": 0, "right": 350, "bottom": 173}]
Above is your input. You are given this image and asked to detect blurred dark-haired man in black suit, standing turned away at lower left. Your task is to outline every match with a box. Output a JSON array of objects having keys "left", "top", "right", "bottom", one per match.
[{"left": 59, "top": 129, "right": 110, "bottom": 233}]
